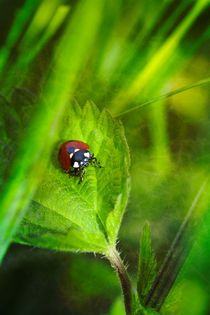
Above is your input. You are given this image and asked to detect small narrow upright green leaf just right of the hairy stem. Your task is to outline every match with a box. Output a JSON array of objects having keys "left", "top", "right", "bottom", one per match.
[{"left": 137, "top": 223, "right": 157, "bottom": 305}]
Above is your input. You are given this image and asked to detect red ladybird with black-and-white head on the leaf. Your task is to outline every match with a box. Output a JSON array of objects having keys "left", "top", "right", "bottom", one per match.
[{"left": 58, "top": 140, "right": 101, "bottom": 183}]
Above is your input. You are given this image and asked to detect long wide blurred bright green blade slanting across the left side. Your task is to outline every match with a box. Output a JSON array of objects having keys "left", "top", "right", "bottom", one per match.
[{"left": 0, "top": 0, "right": 103, "bottom": 261}]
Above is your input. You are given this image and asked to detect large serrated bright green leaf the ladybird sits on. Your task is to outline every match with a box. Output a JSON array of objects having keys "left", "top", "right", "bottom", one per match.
[{"left": 15, "top": 102, "right": 129, "bottom": 253}]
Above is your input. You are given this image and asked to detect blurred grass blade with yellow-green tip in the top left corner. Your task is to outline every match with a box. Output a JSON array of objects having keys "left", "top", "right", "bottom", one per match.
[{"left": 2, "top": 0, "right": 69, "bottom": 94}]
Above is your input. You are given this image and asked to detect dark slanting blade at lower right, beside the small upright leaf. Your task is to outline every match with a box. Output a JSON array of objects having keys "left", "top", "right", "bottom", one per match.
[{"left": 145, "top": 179, "right": 209, "bottom": 310}]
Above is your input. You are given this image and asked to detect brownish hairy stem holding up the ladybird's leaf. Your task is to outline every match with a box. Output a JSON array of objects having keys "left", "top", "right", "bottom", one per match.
[{"left": 106, "top": 248, "right": 132, "bottom": 315}]
